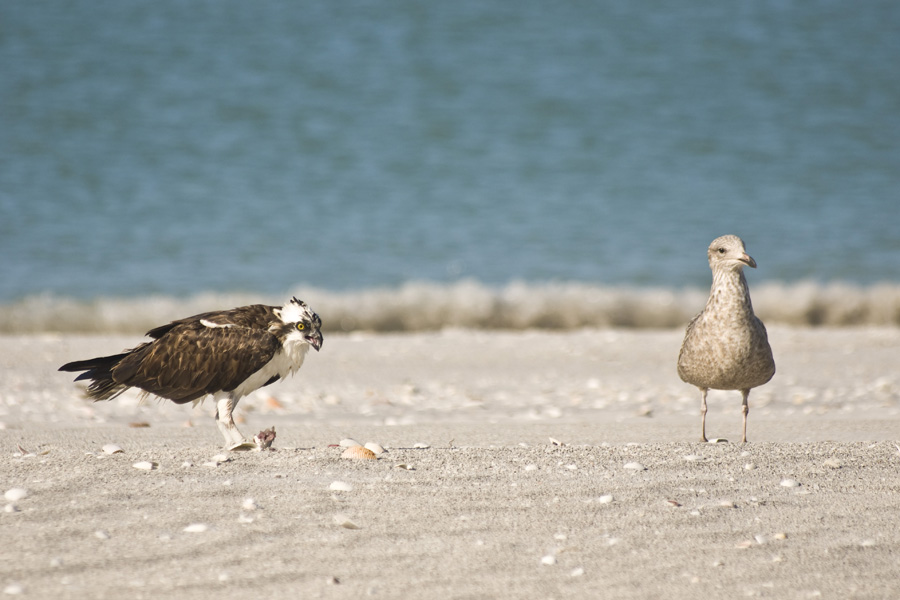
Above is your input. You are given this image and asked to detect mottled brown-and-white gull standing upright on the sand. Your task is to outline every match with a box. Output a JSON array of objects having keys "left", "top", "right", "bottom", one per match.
[{"left": 678, "top": 235, "right": 775, "bottom": 442}]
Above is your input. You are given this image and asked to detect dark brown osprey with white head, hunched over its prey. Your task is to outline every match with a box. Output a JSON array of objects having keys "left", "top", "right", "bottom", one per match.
[{"left": 59, "top": 298, "right": 323, "bottom": 449}]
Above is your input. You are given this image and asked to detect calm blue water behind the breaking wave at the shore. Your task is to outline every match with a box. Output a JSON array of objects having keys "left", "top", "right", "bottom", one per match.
[{"left": 0, "top": 0, "right": 900, "bottom": 303}]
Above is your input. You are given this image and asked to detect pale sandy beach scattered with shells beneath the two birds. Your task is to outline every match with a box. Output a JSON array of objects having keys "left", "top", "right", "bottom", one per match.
[{"left": 0, "top": 327, "right": 900, "bottom": 599}]
